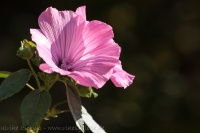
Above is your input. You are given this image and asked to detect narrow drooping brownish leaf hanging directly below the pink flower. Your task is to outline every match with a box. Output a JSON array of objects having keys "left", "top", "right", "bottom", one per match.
[{"left": 66, "top": 82, "right": 84, "bottom": 132}]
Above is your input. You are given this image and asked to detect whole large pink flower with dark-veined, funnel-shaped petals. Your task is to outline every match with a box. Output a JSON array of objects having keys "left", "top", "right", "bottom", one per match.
[{"left": 30, "top": 6, "right": 134, "bottom": 88}]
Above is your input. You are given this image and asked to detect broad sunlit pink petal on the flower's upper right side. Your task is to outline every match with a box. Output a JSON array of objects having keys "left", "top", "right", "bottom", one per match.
[{"left": 73, "top": 20, "right": 121, "bottom": 67}]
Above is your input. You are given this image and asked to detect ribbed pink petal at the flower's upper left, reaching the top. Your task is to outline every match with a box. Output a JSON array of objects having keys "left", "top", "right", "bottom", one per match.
[{"left": 38, "top": 7, "right": 77, "bottom": 61}]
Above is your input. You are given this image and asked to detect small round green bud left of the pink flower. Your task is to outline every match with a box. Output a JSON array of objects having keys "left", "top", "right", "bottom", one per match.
[{"left": 17, "top": 39, "right": 36, "bottom": 59}]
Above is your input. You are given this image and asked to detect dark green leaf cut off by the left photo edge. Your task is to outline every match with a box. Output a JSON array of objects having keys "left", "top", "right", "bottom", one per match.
[{"left": 0, "top": 69, "right": 31, "bottom": 101}]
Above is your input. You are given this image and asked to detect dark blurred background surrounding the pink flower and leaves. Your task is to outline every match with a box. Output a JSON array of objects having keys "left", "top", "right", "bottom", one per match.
[{"left": 0, "top": 0, "right": 200, "bottom": 133}]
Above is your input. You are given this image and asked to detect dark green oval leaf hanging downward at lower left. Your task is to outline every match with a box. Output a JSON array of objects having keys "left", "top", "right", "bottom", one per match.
[{"left": 20, "top": 90, "right": 51, "bottom": 127}]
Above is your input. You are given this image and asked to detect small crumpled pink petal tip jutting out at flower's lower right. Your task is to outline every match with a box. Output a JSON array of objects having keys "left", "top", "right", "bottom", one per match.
[{"left": 110, "top": 65, "right": 135, "bottom": 89}]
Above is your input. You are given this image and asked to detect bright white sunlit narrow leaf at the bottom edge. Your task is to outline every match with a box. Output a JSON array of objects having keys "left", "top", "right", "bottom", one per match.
[{"left": 82, "top": 106, "right": 106, "bottom": 133}]
